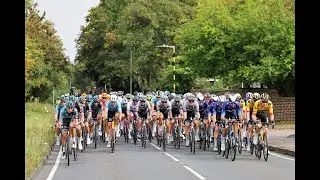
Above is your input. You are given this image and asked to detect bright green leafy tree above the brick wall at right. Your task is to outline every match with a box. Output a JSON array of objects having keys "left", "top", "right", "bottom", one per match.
[{"left": 176, "top": 0, "right": 295, "bottom": 95}]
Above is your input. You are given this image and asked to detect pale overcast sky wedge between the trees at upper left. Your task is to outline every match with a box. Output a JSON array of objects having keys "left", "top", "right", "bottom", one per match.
[{"left": 35, "top": 0, "right": 99, "bottom": 63}]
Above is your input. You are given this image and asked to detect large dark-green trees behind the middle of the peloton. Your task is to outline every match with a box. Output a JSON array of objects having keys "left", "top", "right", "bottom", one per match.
[{"left": 76, "top": 0, "right": 196, "bottom": 90}]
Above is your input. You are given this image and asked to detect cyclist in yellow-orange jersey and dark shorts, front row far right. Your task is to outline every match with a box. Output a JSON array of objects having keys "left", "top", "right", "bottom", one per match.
[{"left": 252, "top": 93, "right": 274, "bottom": 145}]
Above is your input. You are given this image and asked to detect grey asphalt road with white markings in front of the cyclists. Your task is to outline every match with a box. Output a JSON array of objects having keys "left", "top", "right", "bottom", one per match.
[{"left": 33, "top": 137, "right": 295, "bottom": 180}]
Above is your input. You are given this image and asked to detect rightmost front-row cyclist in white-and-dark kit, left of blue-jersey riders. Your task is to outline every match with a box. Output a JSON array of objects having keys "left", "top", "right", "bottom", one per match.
[{"left": 182, "top": 94, "right": 200, "bottom": 147}]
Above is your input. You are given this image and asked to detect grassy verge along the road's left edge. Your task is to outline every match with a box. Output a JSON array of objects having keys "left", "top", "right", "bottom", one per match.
[{"left": 25, "top": 102, "right": 55, "bottom": 179}]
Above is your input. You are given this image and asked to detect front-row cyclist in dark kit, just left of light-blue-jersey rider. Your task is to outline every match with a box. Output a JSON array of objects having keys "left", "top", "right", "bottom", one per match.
[{"left": 87, "top": 96, "right": 102, "bottom": 144}]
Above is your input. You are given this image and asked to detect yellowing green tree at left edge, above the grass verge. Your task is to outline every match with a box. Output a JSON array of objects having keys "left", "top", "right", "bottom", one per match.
[{"left": 25, "top": 0, "right": 70, "bottom": 101}]
